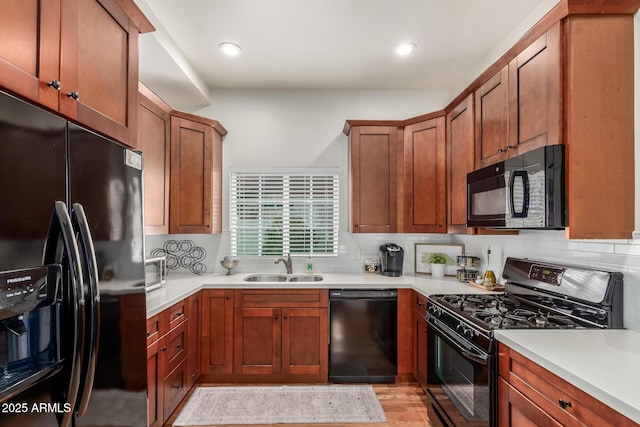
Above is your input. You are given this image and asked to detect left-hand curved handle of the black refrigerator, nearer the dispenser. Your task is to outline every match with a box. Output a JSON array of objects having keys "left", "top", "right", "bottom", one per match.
[{"left": 43, "top": 201, "right": 85, "bottom": 427}]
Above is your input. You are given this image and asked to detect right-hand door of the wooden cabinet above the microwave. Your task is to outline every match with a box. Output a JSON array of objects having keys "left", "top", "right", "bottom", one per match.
[{"left": 507, "top": 23, "right": 562, "bottom": 156}]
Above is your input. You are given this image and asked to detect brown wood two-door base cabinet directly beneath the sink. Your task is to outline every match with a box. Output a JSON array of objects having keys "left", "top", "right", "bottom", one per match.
[{"left": 233, "top": 289, "right": 329, "bottom": 382}]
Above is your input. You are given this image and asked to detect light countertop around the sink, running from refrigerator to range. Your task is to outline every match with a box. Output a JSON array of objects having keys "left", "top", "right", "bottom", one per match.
[{"left": 147, "top": 273, "right": 496, "bottom": 317}]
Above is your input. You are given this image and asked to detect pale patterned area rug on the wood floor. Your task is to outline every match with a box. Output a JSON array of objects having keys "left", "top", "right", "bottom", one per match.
[{"left": 173, "top": 385, "right": 387, "bottom": 426}]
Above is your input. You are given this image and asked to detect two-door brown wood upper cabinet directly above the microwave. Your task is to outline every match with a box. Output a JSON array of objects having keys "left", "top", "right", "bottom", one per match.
[{"left": 475, "top": 23, "right": 562, "bottom": 169}]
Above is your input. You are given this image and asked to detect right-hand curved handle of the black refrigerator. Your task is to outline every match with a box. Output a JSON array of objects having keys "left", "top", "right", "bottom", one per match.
[{"left": 71, "top": 203, "right": 100, "bottom": 416}]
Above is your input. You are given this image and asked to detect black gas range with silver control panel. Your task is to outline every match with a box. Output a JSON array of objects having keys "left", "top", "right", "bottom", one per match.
[{"left": 426, "top": 258, "right": 623, "bottom": 427}]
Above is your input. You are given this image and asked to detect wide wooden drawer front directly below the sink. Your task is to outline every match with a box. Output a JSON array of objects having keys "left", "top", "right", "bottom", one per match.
[{"left": 234, "top": 289, "right": 329, "bottom": 307}]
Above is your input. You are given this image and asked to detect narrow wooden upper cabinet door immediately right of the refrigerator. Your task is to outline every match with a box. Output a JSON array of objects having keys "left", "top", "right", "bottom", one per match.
[{"left": 137, "top": 86, "right": 171, "bottom": 234}]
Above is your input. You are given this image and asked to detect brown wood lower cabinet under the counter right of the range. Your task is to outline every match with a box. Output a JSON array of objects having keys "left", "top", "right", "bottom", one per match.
[{"left": 498, "top": 343, "right": 638, "bottom": 427}]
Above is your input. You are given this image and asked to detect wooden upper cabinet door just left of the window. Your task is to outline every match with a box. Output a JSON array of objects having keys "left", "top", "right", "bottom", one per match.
[{"left": 169, "top": 116, "right": 213, "bottom": 234}]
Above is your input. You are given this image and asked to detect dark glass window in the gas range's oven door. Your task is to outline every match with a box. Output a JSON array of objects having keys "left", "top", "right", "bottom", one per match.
[{"left": 434, "top": 336, "right": 491, "bottom": 422}]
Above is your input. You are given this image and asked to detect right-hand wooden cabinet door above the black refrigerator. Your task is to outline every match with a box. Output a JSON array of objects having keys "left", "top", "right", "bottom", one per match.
[{"left": 59, "top": 0, "right": 138, "bottom": 145}]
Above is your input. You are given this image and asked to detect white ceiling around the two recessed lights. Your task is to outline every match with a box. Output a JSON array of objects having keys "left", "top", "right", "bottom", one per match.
[{"left": 136, "top": 0, "right": 555, "bottom": 109}]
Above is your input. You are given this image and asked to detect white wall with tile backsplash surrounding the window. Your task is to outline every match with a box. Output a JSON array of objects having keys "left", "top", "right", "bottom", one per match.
[{"left": 146, "top": 10, "right": 640, "bottom": 332}]
